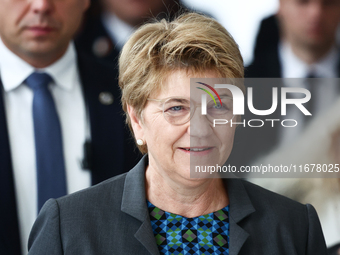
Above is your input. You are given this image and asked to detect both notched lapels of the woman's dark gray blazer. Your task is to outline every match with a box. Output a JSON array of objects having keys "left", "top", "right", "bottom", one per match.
[{"left": 121, "top": 155, "right": 255, "bottom": 255}]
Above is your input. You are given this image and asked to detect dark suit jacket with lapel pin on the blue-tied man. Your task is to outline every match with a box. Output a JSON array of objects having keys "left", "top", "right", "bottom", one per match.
[{"left": 0, "top": 49, "right": 140, "bottom": 255}]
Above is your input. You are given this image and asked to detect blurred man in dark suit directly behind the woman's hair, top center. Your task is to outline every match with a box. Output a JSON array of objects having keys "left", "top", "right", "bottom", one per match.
[{"left": 76, "top": 0, "right": 205, "bottom": 66}]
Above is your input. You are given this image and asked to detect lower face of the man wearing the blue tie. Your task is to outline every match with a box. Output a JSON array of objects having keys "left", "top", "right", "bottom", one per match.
[{"left": 0, "top": 0, "right": 89, "bottom": 65}]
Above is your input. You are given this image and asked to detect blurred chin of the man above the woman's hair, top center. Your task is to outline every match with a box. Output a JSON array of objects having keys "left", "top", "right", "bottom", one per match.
[{"left": 102, "top": 0, "right": 173, "bottom": 26}]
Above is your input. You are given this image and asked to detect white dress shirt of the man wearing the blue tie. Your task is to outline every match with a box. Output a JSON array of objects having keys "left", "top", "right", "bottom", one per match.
[{"left": 0, "top": 40, "right": 91, "bottom": 254}]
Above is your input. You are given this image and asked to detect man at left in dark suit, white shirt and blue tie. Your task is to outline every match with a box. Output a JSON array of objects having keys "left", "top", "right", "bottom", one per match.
[{"left": 0, "top": 0, "right": 139, "bottom": 255}]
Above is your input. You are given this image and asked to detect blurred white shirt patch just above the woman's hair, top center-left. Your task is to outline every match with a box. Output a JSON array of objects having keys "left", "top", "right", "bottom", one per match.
[{"left": 102, "top": 13, "right": 136, "bottom": 49}]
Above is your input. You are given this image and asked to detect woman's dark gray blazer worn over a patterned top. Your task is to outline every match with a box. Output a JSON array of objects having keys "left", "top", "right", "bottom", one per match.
[{"left": 28, "top": 157, "right": 326, "bottom": 255}]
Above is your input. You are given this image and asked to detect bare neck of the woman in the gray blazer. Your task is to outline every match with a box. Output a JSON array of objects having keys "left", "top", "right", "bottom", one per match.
[{"left": 146, "top": 165, "right": 229, "bottom": 218}]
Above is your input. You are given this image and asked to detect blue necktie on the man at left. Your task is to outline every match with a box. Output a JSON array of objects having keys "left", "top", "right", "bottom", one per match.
[{"left": 25, "top": 73, "right": 67, "bottom": 212}]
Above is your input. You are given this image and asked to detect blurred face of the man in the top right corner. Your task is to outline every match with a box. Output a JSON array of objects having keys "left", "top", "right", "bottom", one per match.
[{"left": 278, "top": 0, "right": 340, "bottom": 48}]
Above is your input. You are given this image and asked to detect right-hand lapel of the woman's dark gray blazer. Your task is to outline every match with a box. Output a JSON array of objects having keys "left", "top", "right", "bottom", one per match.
[{"left": 226, "top": 179, "right": 255, "bottom": 255}]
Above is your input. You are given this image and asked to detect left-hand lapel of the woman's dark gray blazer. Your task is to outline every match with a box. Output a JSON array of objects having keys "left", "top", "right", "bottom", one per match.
[{"left": 121, "top": 156, "right": 159, "bottom": 255}]
